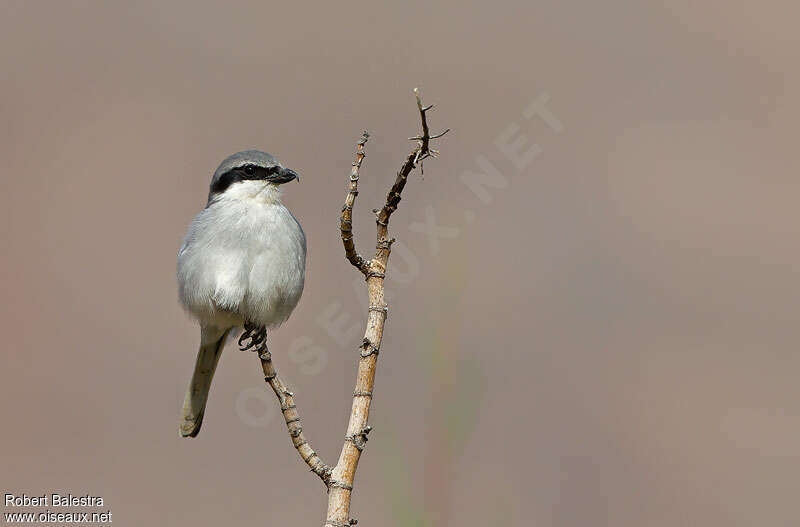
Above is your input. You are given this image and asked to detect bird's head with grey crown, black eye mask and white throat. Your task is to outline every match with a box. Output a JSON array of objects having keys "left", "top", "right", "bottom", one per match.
[{"left": 208, "top": 150, "right": 300, "bottom": 203}]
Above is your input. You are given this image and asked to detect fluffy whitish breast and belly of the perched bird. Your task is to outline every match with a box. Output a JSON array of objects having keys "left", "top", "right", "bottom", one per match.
[{"left": 178, "top": 181, "right": 306, "bottom": 327}]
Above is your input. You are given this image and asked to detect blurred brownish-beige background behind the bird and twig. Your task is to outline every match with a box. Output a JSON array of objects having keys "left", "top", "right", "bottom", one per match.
[{"left": 0, "top": 0, "right": 800, "bottom": 527}]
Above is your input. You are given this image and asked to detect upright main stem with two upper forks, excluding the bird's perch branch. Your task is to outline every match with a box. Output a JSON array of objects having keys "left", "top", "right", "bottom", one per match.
[{"left": 325, "top": 89, "right": 447, "bottom": 527}]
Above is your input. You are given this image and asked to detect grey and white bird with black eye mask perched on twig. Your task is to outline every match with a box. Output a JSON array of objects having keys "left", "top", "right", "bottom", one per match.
[{"left": 177, "top": 150, "right": 306, "bottom": 437}]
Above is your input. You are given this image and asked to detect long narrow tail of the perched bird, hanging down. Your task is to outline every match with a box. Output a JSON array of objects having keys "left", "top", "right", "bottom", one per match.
[{"left": 180, "top": 328, "right": 230, "bottom": 437}]
